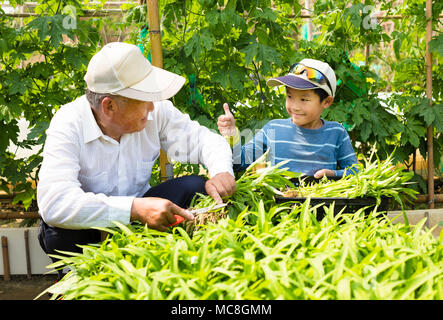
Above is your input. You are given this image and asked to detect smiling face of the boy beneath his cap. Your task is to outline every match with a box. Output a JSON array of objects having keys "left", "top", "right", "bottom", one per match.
[{"left": 286, "top": 87, "right": 334, "bottom": 129}]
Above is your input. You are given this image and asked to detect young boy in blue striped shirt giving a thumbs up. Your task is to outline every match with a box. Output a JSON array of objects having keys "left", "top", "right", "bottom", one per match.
[{"left": 217, "top": 59, "right": 357, "bottom": 178}]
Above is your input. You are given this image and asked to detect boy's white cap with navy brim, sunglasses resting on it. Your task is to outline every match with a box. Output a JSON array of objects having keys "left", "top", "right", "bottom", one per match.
[{"left": 266, "top": 59, "right": 337, "bottom": 97}]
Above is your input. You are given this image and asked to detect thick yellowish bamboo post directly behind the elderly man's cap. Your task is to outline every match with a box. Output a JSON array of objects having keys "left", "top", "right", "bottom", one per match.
[{"left": 147, "top": 0, "right": 173, "bottom": 181}]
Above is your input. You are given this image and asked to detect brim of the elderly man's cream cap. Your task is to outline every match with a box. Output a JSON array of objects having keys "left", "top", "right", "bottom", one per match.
[{"left": 113, "top": 66, "right": 186, "bottom": 102}]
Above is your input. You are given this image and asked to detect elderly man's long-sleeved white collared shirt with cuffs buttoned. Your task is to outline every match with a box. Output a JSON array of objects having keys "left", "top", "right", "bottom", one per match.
[{"left": 37, "top": 96, "right": 233, "bottom": 229}]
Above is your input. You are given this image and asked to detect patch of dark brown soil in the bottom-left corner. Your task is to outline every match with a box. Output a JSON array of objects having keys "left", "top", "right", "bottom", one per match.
[{"left": 0, "top": 274, "right": 57, "bottom": 300}]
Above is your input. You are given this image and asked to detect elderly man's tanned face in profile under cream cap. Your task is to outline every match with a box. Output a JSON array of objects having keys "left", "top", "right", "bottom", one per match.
[{"left": 112, "top": 97, "right": 154, "bottom": 134}]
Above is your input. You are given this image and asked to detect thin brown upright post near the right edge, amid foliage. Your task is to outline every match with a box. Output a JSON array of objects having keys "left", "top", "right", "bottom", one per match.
[{"left": 426, "top": 0, "right": 435, "bottom": 209}]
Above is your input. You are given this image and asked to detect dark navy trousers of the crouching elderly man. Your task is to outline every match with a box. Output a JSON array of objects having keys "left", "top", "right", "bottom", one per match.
[{"left": 38, "top": 175, "right": 206, "bottom": 277}]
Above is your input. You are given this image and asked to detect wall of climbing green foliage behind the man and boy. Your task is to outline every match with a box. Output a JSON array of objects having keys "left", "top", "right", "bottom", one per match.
[{"left": 0, "top": 0, "right": 443, "bottom": 205}]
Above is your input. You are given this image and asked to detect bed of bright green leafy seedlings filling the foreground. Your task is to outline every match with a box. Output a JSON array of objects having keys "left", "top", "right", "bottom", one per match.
[{"left": 42, "top": 159, "right": 443, "bottom": 300}]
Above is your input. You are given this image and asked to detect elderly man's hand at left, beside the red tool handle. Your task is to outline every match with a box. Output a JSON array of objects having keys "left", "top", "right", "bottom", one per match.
[{"left": 131, "top": 197, "right": 194, "bottom": 231}]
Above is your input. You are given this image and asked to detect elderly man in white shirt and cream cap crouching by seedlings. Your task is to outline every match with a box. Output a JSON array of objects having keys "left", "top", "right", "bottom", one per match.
[{"left": 37, "top": 42, "right": 235, "bottom": 274}]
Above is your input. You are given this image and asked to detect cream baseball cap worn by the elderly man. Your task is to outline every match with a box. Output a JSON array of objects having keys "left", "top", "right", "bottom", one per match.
[{"left": 84, "top": 42, "right": 185, "bottom": 101}]
